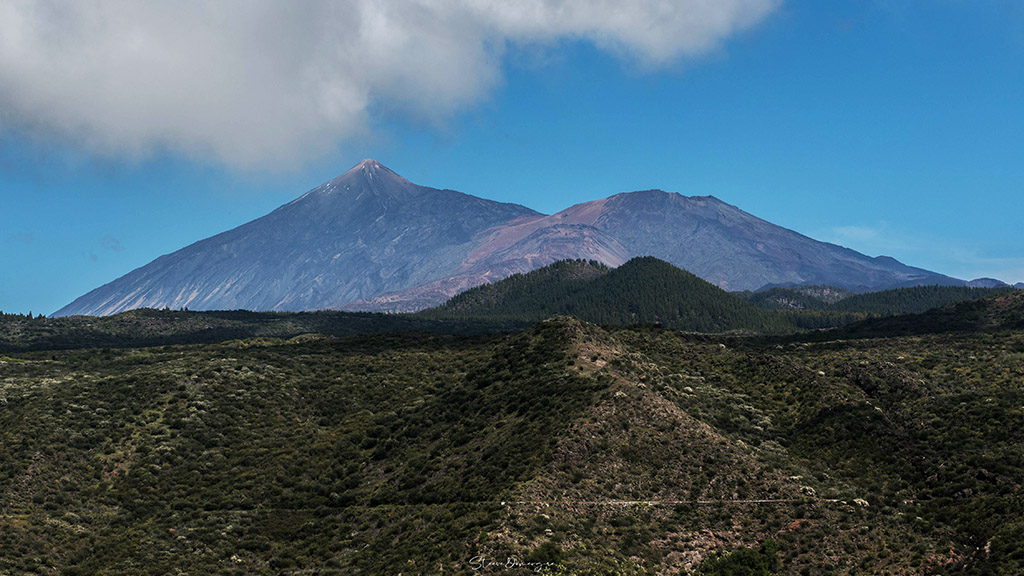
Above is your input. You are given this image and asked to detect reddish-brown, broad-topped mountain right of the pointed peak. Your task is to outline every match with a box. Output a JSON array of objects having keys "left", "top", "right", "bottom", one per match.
[{"left": 344, "top": 190, "right": 964, "bottom": 311}]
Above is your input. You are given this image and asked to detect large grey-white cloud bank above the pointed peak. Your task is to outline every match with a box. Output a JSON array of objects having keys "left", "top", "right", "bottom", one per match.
[{"left": 0, "top": 0, "right": 781, "bottom": 169}]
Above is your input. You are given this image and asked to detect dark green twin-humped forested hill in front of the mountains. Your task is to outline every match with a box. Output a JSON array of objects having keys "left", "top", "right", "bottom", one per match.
[{"left": 422, "top": 256, "right": 793, "bottom": 333}]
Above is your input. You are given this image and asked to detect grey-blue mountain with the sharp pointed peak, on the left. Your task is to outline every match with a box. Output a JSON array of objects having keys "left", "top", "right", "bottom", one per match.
[{"left": 55, "top": 160, "right": 539, "bottom": 316}]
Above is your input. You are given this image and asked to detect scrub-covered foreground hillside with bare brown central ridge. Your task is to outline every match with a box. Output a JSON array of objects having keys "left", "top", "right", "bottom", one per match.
[{"left": 0, "top": 291, "right": 1024, "bottom": 575}]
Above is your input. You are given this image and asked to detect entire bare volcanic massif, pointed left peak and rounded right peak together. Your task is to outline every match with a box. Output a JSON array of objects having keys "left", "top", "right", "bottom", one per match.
[{"left": 54, "top": 160, "right": 963, "bottom": 316}]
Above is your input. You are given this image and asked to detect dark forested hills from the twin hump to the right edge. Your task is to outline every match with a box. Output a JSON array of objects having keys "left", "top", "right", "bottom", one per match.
[{"left": 417, "top": 256, "right": 1013, "bottom": 334}]
